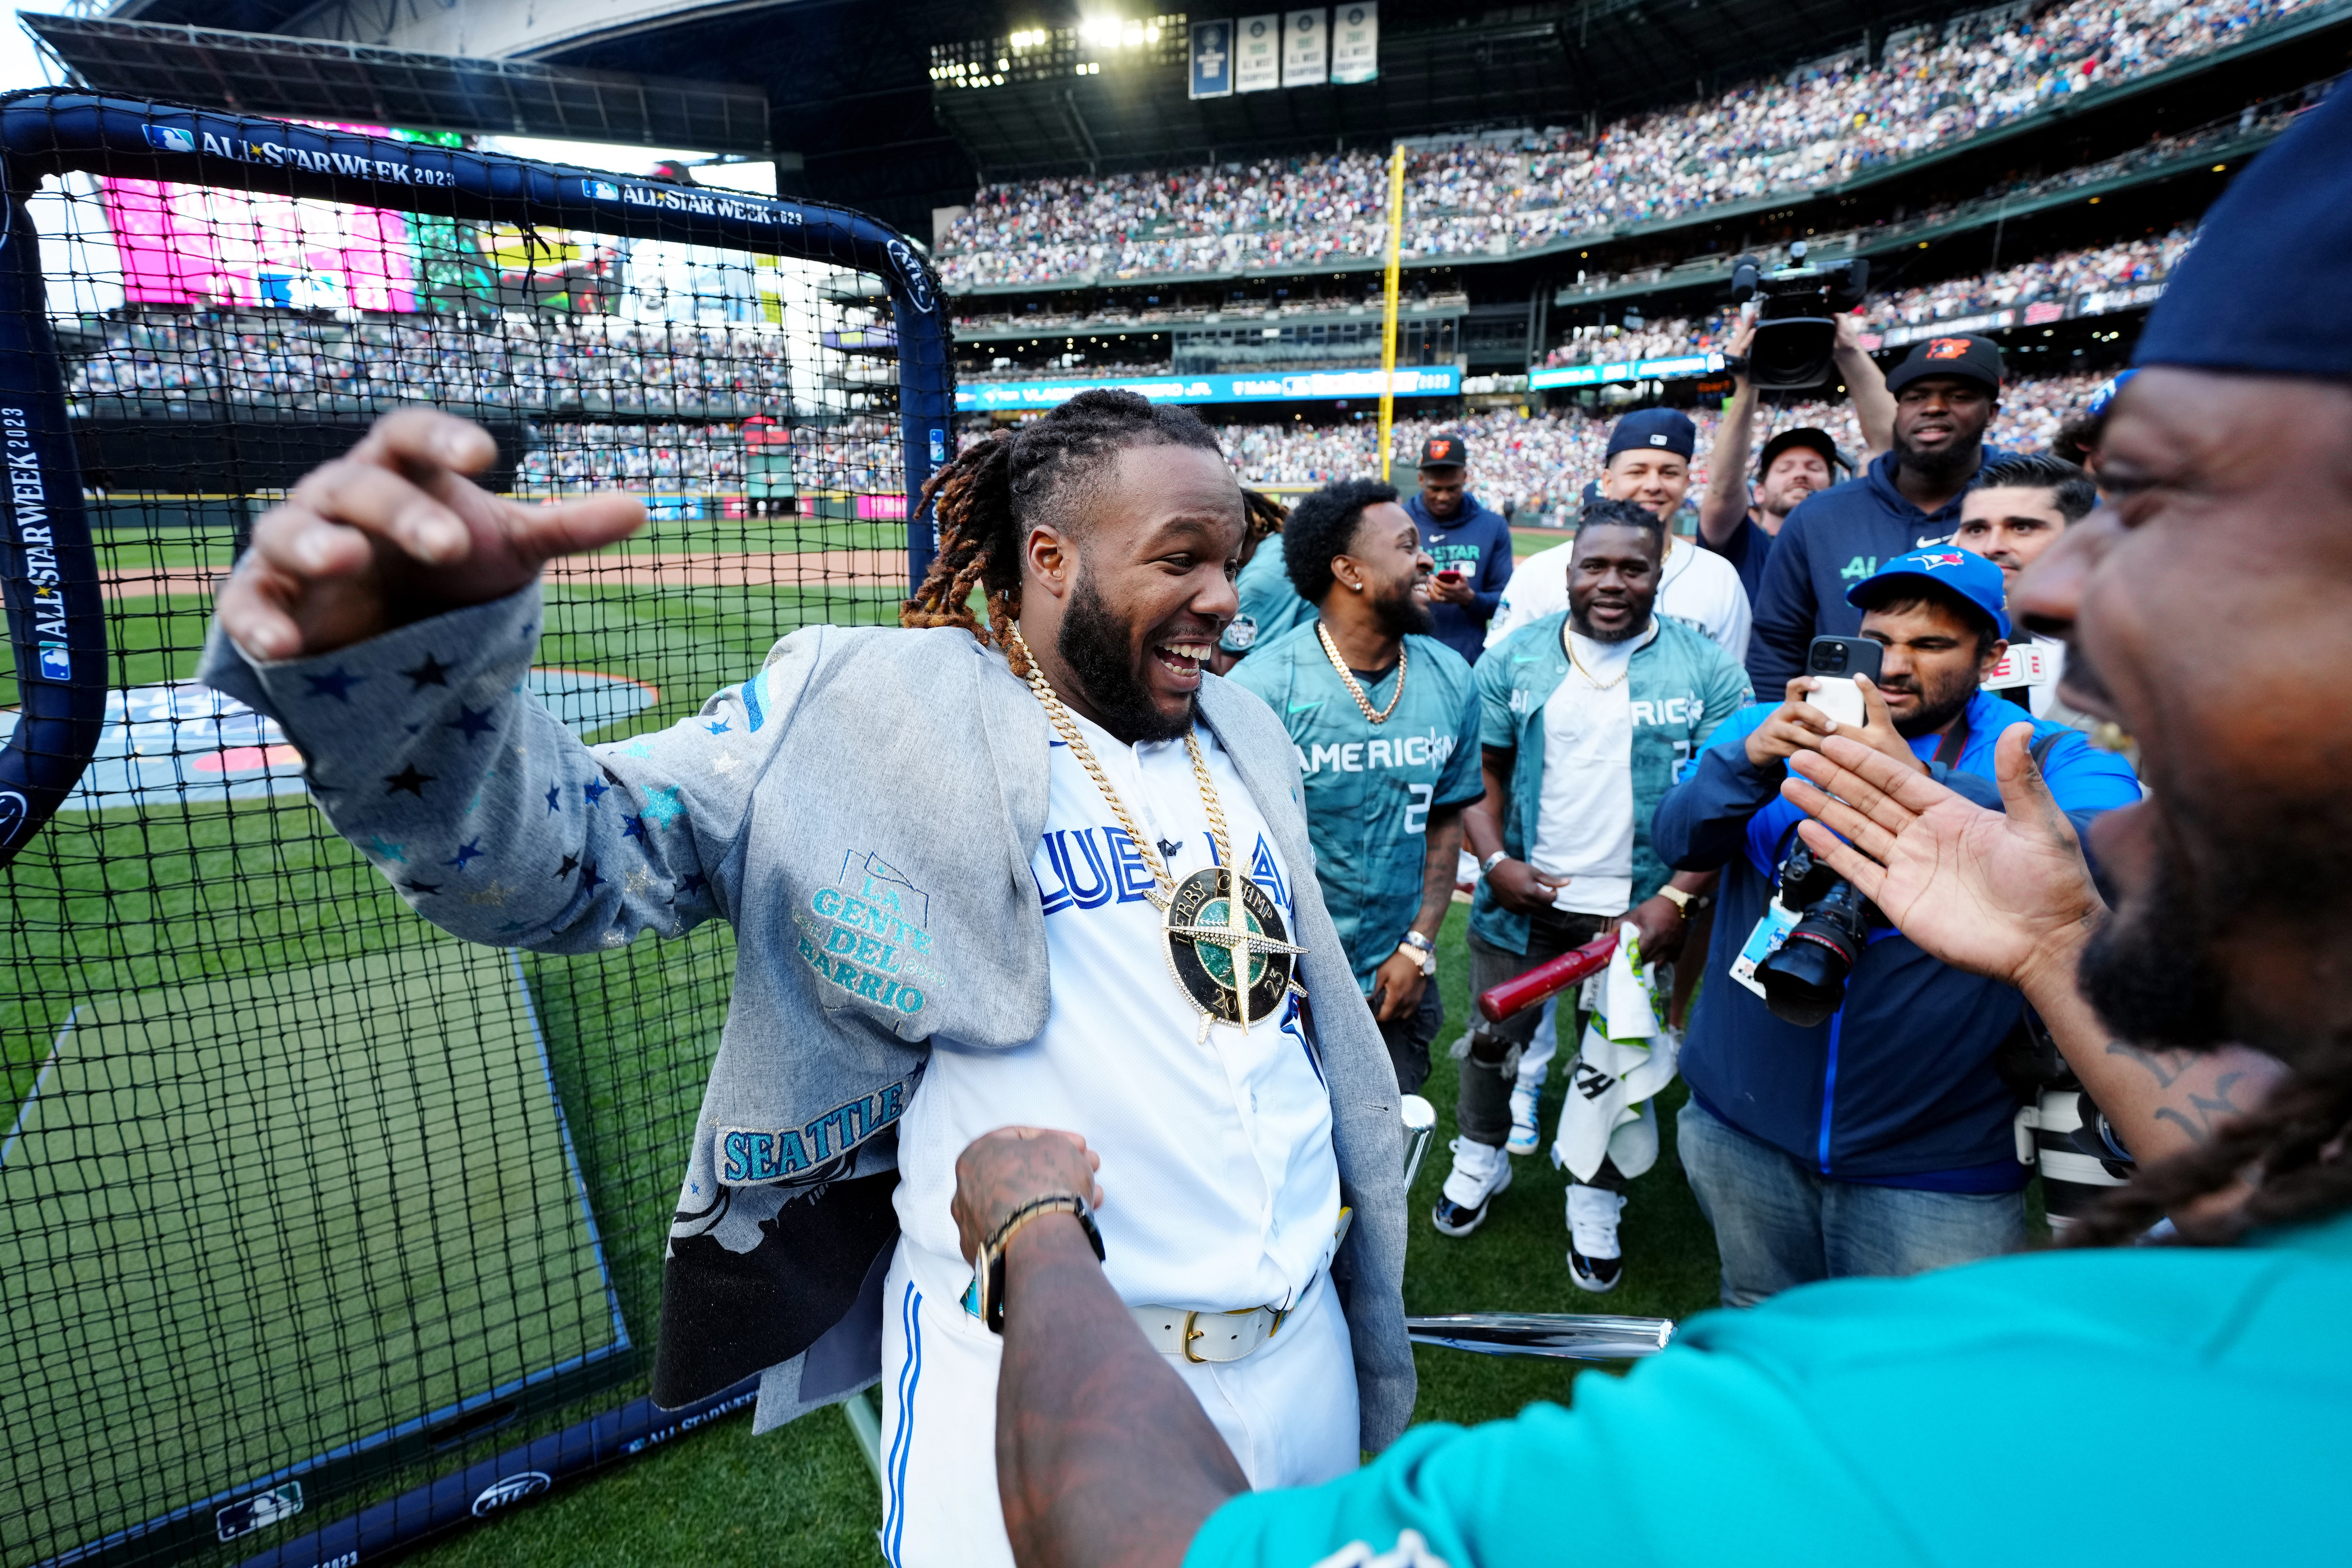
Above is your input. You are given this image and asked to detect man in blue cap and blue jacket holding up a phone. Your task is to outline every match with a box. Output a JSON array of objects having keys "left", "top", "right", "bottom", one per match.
[{"left": 1651, "top": 545, "right": 2140, "bottom": 1307}]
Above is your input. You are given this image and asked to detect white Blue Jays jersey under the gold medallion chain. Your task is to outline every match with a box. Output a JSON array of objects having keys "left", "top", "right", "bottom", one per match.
[{"left": 896, "top": 720, "right": 1338, "bottom": 1312}]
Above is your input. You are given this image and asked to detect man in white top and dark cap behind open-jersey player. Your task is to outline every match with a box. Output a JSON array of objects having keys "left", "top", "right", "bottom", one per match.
[{"left": 1486, "top": 409, "right": 1748, "bottom": 661}]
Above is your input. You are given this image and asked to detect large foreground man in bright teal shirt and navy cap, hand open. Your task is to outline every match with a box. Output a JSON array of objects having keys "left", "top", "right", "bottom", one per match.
[{"left": 912, "top": 94, "right": 2352, "bottom": 1568}]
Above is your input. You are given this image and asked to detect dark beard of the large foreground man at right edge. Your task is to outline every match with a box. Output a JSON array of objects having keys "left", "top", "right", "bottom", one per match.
[{"left": 2077, "top": 846, "right": 2230, "bottom": 1051}]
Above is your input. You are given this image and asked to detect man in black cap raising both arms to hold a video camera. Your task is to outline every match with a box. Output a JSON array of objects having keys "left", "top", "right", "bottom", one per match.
[{"left": 1698, "top": 312, "right": 1896, "bottom": 606}]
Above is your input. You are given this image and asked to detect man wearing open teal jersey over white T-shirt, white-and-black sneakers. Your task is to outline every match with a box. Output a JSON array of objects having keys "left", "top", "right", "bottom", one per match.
[{"left": 1430, "top": 501, "right": 1748, "bottom": 1291}]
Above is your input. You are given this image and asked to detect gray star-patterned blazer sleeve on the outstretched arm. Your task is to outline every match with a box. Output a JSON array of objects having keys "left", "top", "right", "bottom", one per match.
[{"left": 198, "top": 585, "right": 786, "bottom": 952}]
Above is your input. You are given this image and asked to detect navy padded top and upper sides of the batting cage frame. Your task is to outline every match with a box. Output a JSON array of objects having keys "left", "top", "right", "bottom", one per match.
[{"left": 0, "top": 90, "right": 955, "bottom": 865}]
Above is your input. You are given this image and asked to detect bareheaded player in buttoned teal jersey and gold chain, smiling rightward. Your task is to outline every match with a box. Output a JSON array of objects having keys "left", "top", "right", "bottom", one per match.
[{"left": 1233, "top": 479, "right": 1482, "bottom": 1093}]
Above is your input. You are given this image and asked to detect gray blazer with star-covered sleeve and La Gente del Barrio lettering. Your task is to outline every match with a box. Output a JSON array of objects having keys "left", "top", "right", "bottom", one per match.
[{"left": 200, "top": 585, "right": 1413, "bottom": 1448}]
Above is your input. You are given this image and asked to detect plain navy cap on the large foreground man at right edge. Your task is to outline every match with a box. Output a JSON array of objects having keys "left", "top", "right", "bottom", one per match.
[{"left": 2133, "top": 87, "right": 2352, "bottom": 381}]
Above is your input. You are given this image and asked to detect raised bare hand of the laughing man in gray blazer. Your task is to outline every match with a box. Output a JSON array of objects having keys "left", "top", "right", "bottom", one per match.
[{"left": 216, "top": 409, "right": 645, "bottom": 658}]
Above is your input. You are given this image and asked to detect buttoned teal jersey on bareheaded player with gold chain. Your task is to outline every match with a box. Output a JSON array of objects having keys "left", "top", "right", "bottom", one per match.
[{"left": 1233, "top": 618, "right": 1484, "bottom": 992}]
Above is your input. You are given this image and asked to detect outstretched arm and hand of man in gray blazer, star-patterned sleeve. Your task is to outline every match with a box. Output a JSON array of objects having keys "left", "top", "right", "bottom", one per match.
[{"left": 204, "top": 409, "right": 762, "bottom": 950}]
